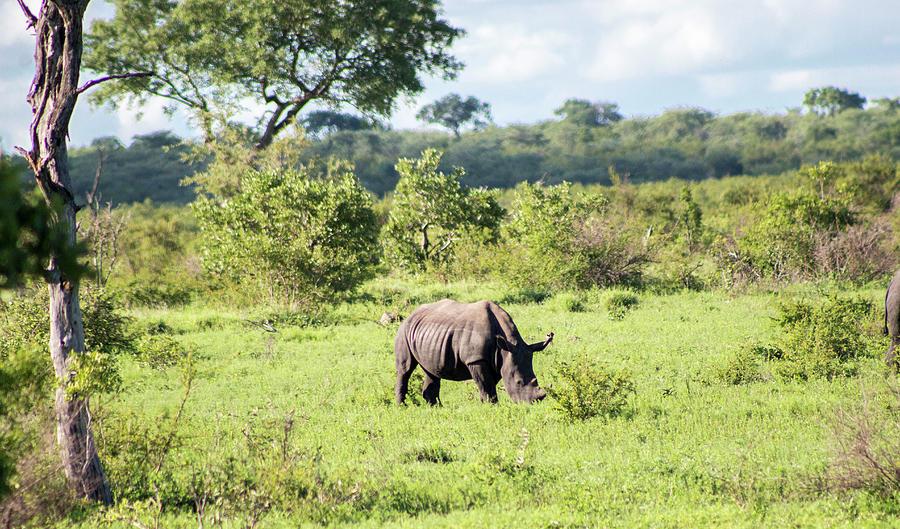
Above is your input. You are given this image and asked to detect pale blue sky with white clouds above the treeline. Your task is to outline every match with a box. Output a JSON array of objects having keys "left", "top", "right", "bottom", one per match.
[{"left": 0, "top": 0, "right": 900, "bottom": 152}]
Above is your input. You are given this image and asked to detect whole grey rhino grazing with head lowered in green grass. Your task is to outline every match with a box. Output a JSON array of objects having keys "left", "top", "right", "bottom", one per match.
[{"left": 394, "top": 299, "right": 553, "bottom": 405}]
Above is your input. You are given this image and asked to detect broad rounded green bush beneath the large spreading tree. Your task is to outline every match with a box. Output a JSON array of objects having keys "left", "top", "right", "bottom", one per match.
[{"left": 193, "top": 167, "right": 378, "bottom": 303}]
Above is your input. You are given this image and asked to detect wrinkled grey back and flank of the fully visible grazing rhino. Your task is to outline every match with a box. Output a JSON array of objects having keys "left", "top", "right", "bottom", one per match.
[{"left": 395, "top": 299, "right": 502, "bottom": 380}]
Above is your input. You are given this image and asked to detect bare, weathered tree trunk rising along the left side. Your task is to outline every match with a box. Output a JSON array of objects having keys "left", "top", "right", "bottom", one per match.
[{"left": 19, "top": 0, "right": 112, "bottom": 504}]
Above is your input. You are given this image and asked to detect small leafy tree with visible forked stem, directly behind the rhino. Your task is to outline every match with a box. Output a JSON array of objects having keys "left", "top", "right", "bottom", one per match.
[{"left": 383, "top": 149, "right": 505, "bottom": 271}]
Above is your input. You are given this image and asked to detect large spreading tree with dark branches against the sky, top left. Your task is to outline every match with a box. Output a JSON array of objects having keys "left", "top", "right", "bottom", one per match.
[{"left": 85, "top": 0, "right": 463, "bottom": 150}]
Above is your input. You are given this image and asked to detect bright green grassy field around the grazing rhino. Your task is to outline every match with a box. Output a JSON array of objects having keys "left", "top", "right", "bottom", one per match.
[{"left": 80, "top": 280, "right": 900, "bottom": 528}]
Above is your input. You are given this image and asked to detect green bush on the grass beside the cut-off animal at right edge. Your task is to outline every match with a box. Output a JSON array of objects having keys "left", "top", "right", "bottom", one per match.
[{"left": 776, "top": 296, "right": 877, "bottom": 379}]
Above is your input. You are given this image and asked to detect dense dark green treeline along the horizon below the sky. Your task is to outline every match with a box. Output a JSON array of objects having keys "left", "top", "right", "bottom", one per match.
[{"left": 40, "top": 100, "right": 900, "bottom": 204}]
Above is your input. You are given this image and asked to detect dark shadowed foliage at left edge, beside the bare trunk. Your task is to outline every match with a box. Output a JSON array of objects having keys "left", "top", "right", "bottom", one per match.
[{"left": 0, "top": 156, "right": 84, "bottom": 290}]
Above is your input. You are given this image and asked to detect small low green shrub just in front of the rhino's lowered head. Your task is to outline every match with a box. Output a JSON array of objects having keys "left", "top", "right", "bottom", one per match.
[{"left": 546, "top": 358, "right": 634, "bottom": 422}]
